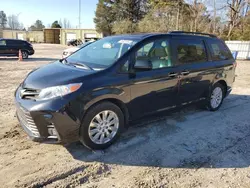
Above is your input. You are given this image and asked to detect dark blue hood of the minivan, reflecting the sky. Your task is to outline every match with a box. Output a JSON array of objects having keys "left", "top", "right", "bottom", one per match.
[{"left": 22, "top": 61, "right": 96, "bottom": 89}]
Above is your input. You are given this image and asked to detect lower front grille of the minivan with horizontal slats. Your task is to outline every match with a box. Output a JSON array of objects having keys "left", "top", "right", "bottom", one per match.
[{"left": 16, "top": 104, "right": 40, "bottom": 137}]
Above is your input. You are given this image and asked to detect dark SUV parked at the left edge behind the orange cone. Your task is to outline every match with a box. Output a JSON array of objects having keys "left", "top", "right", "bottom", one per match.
[{"left": 0, "top": 38, "right": 35, "bottom": 59}]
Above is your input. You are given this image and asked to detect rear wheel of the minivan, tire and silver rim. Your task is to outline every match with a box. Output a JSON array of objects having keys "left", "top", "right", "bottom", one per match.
[{"left": 206, "top": 83, "right": 226, "bottom": 111}]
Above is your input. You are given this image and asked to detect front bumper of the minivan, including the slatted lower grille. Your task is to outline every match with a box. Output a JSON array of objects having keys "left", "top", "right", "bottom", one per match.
[{"left": 15, "top": 88, "right": 80, "bottom": 143}]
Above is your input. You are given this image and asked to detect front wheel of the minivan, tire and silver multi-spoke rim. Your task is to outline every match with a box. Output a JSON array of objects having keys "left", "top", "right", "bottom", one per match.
[{"left": 80, "top": 102, "right": 124, "bottom": 150}]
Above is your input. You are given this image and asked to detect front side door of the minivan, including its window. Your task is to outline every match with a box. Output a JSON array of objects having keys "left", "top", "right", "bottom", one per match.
[{"left": 130, "top": 38, "right": 178, "bottom": 116}]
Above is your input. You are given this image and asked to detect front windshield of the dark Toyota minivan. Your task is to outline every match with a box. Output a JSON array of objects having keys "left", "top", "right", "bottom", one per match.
[{"left": 66, "top": 37, "right": 137, "bottom": 68}]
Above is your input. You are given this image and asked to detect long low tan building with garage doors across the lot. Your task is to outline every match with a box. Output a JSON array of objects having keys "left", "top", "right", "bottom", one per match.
[{"left": 0, "top": 28, "right": 103, "bottom": 45}]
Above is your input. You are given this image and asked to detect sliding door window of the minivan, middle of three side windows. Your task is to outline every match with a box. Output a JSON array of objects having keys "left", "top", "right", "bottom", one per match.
[{"left": 176, "top": 39, "right": 207, "bottom": 64}]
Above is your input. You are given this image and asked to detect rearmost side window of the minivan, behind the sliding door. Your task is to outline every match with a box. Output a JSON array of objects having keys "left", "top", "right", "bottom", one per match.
[{"left": 208, "top": 40, "right": 233, "bottom": 61}]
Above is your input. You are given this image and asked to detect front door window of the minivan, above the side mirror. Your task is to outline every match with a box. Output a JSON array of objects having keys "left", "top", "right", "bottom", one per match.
[{"left": 136, "top": 39, "right": 172, "bottom": 69}]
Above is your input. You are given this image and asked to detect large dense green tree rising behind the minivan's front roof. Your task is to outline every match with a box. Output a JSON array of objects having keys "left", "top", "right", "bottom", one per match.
[{"left": 94, "top": 0, "right": 149, "bottom": 35}]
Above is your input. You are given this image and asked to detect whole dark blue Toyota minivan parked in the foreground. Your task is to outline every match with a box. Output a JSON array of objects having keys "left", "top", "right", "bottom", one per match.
[{"left": 15, "top": 31, "right": 236, "bottom": 149}]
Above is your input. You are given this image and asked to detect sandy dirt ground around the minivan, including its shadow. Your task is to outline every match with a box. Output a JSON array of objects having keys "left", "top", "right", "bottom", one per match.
[{"left": 0, "top": 44, "right": 250, "bottom": 188}]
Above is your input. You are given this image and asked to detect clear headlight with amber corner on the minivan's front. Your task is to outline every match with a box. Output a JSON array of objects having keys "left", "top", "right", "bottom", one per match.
[{"left": 38, "top": 83, "right": 82, "bottom": 100}]
